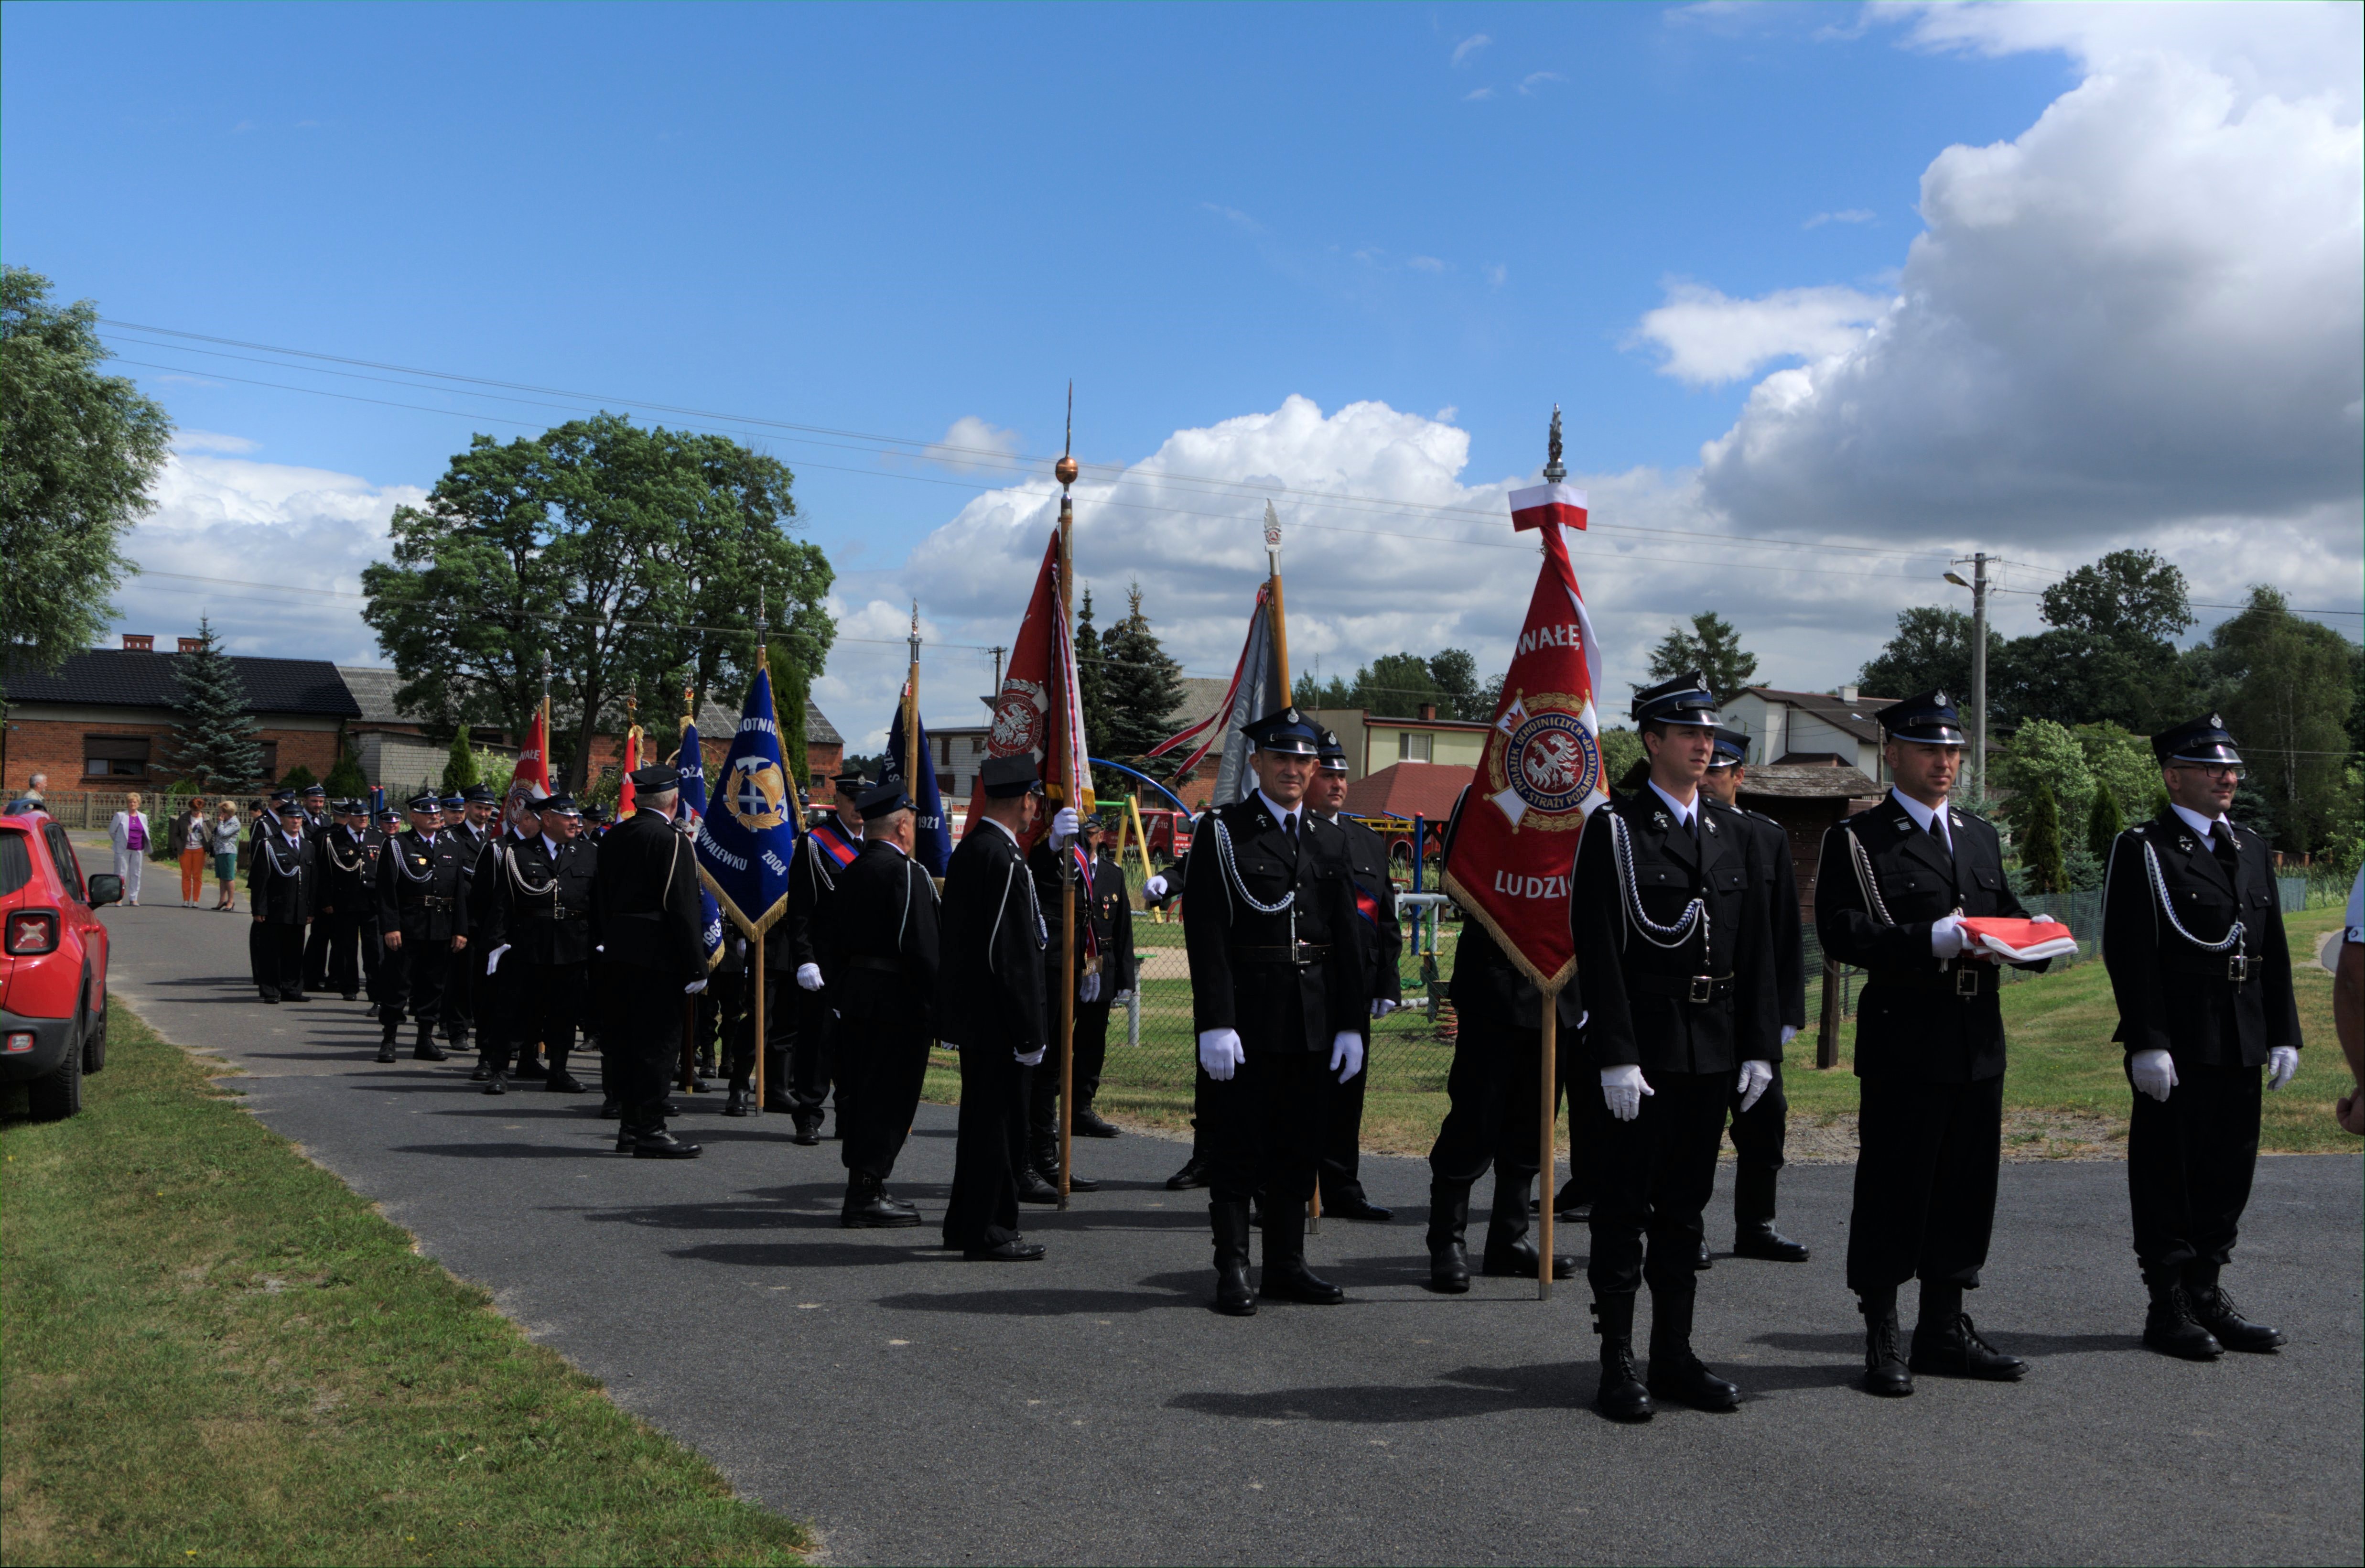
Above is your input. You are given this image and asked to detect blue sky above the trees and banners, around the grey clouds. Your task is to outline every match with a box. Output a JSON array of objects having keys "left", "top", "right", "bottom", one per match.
[{"left": 0, "top": 5, "right": 2358, "bottom": 747}]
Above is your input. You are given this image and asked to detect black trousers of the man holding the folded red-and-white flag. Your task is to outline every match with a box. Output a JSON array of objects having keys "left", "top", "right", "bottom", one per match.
[{"left": 1847, "top": 1074, "right": 2003, "bottom": 1296}]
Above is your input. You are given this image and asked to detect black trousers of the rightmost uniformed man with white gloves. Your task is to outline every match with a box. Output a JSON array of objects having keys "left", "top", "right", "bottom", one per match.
[{"left": 2126, "top": 1062, "right": 2261, "bottom": 1284}]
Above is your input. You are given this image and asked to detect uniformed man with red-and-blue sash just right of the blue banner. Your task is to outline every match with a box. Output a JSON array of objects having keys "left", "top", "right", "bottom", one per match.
[{"left": 764, "top": 768, "right": 870, "bottom": 1145}]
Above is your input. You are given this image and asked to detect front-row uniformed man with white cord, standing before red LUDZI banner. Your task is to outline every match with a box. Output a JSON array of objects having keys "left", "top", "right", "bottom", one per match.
[{"left": 1570, "top": 671, "right": 1781, "bottom": 1421}]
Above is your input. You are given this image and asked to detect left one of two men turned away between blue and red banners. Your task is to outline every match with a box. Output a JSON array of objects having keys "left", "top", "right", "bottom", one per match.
[{"left": 830, "top": 783, "right": 937, "bottom": 1227}]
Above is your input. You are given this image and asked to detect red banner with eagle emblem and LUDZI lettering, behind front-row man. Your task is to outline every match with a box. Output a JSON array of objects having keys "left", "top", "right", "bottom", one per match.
[{"left": 1445, "top": 485, "right": 1608, "bottom": 991}]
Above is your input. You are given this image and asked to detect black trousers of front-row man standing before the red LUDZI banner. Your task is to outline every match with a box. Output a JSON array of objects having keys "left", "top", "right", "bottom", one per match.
[{"left": 1570, "top": 1071, "right": 1734, "bottom": 1296}]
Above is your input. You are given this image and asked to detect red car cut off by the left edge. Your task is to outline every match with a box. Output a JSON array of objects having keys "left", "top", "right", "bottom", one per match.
[{"left": 0, "top": 811, "right": 123, "bottom": 1121}]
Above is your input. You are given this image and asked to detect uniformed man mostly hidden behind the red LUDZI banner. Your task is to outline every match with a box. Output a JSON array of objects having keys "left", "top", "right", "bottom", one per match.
[{"left": 1428, "top": 790, "right": 1592, "bottom": 1296}]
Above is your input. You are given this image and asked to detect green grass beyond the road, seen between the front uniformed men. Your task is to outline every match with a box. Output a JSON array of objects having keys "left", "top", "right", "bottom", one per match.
[{"left": 927, "top": 908, "right": 2358, "bottom": 1154}]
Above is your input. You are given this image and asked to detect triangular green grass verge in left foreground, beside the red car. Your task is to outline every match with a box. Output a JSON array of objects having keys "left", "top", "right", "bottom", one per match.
[{"left": 0, "top": 1000, "right": 809, "bottom": 1563}]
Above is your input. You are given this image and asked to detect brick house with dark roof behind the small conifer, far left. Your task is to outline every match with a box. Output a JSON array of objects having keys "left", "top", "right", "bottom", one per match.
[{"left": 0, "top": 634, "right": 359, "bottom": 792}]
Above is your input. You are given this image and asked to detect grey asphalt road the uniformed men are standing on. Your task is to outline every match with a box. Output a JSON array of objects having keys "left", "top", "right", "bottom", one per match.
[{"left": 107, "top": 906, "right": 2365, "bottom": 1563}]
